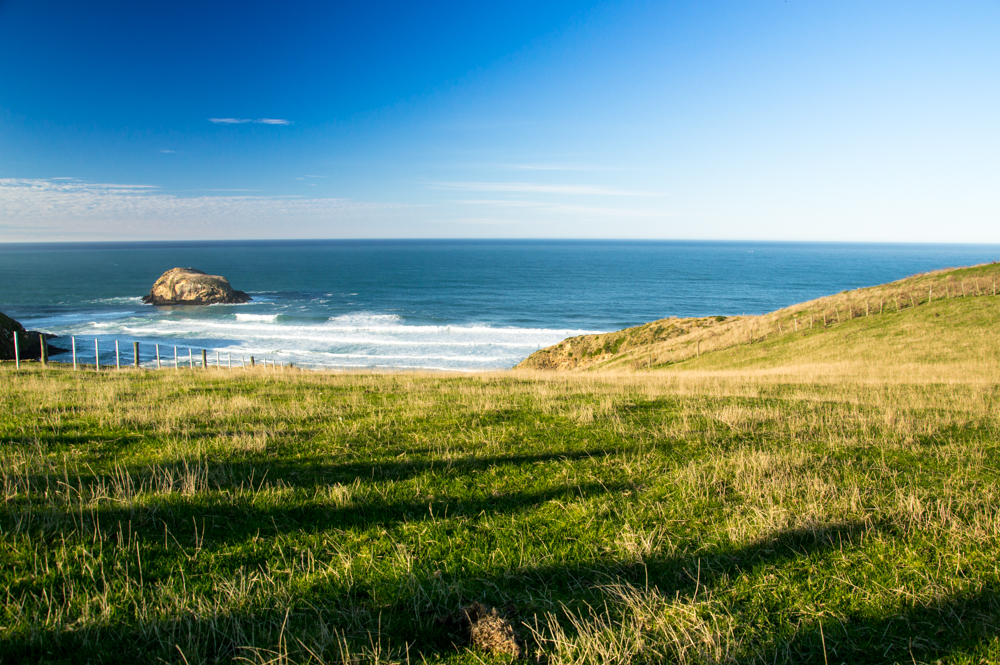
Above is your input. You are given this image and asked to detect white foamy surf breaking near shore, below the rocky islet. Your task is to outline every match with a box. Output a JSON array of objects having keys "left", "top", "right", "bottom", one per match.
[{"left": 35, "top": 310, "right": 592, "bottom": 370}]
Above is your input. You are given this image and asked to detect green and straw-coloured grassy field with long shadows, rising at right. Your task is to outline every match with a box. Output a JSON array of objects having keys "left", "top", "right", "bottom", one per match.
[{"left": 0, "top": 282, "right": 1000, "bottom": 665}]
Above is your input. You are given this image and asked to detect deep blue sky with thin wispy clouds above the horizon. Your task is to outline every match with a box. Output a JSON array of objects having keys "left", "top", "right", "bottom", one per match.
[{"left": 0, "top": 0, "right": 1000, "bottom": 242}]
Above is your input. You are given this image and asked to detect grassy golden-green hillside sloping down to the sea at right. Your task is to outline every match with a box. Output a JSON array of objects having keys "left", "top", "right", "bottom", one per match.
[{"left": 518, "top": 263, "right": 1000, "bottom": 370}]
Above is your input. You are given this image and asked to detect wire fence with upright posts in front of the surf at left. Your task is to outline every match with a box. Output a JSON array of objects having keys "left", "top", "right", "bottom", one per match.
[{"left": 13, "top": 332, "right": 292, "bottom": 372}]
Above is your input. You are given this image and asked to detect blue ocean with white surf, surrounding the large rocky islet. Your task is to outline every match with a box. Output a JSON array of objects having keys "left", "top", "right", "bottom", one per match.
[{"left": 0, "top": 240, "right": 1000, "bottom": 371}]
